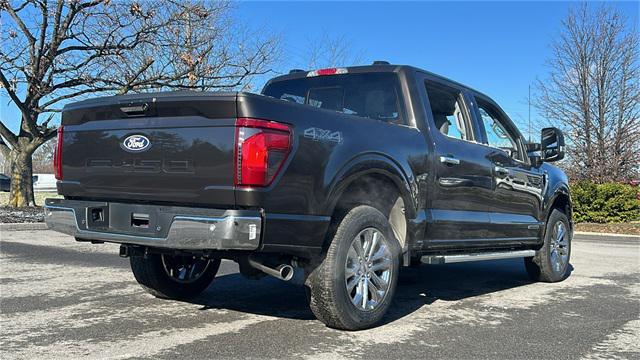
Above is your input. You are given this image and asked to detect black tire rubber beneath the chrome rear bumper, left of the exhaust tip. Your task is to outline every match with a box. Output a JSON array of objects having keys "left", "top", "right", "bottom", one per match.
[{"left": 130, "top": 254, "right": 220, "bottom": 300}]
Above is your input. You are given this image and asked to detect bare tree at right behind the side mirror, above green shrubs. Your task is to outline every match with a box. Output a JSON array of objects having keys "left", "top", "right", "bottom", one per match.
[{"left": 536, "top": 4, "right": 640, "bottom": 182}]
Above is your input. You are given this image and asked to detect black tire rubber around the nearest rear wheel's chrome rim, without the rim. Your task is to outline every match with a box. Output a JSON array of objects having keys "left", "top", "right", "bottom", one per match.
[{"left": 306, "top": 205, "right": 401, "bottom": 330}]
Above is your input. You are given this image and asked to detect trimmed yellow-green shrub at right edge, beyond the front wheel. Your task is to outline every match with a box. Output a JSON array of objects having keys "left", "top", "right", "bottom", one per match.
[{"left": 571, "top": 181, "right": 640, "bottom": 223}]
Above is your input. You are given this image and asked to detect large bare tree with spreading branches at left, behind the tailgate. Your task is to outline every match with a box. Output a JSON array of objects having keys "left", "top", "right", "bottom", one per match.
[{"left": 0, "top": 0, "right": 279, "bottom": 206}]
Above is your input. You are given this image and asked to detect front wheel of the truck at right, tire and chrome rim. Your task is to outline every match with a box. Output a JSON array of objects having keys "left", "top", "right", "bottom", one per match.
[{"left": 524, "top": 209, "right": 571, "bottom": 282}]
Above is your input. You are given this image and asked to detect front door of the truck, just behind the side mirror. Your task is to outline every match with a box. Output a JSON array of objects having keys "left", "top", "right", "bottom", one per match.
[{"left": 473, "top": 95, "right": 545, "bottom": 245}]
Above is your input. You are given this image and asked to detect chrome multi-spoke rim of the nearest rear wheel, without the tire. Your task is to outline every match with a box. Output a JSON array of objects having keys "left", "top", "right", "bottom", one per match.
[{"left": 344, "top": 228, "right": 393, "bottom": 311}]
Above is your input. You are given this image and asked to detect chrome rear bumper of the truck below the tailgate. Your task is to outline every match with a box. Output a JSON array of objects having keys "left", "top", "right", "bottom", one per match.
[{"left": 44, "top": 199, "right": 262, "bottom": 250}]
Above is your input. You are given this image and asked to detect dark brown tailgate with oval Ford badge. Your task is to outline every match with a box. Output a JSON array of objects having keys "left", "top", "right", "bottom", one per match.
[{"left": 58, "top": 92, "right": 236, "bottom": 206}]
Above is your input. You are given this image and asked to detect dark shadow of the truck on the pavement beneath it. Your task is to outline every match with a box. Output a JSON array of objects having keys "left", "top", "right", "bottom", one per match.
[{"left": 185, "top": 259, "right": 568, "bottom": 324}]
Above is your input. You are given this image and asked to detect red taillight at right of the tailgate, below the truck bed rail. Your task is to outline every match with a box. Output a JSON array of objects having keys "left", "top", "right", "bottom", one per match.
[{"left": 235, "top": 118, "right": 291, "bottom": 186}]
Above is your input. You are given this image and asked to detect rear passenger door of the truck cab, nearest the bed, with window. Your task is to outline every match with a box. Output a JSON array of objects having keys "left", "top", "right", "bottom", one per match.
[{"left": 425, "top": 80, "right": 494, "bottom": 249}]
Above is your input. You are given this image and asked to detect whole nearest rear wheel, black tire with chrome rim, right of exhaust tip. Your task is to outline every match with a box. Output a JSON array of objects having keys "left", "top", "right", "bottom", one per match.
[{"left": 307, "top": 206, "right": 400, "bottom": 330}]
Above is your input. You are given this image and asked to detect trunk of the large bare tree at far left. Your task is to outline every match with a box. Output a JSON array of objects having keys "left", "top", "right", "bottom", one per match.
[{"left": 7, "top": 147, "right": 35, "bottom": 207}]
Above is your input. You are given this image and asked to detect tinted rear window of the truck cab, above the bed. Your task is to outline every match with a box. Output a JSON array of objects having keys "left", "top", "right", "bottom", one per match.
[{"left": 262, "top": 73, "right": 404, "bottom": 124}]
